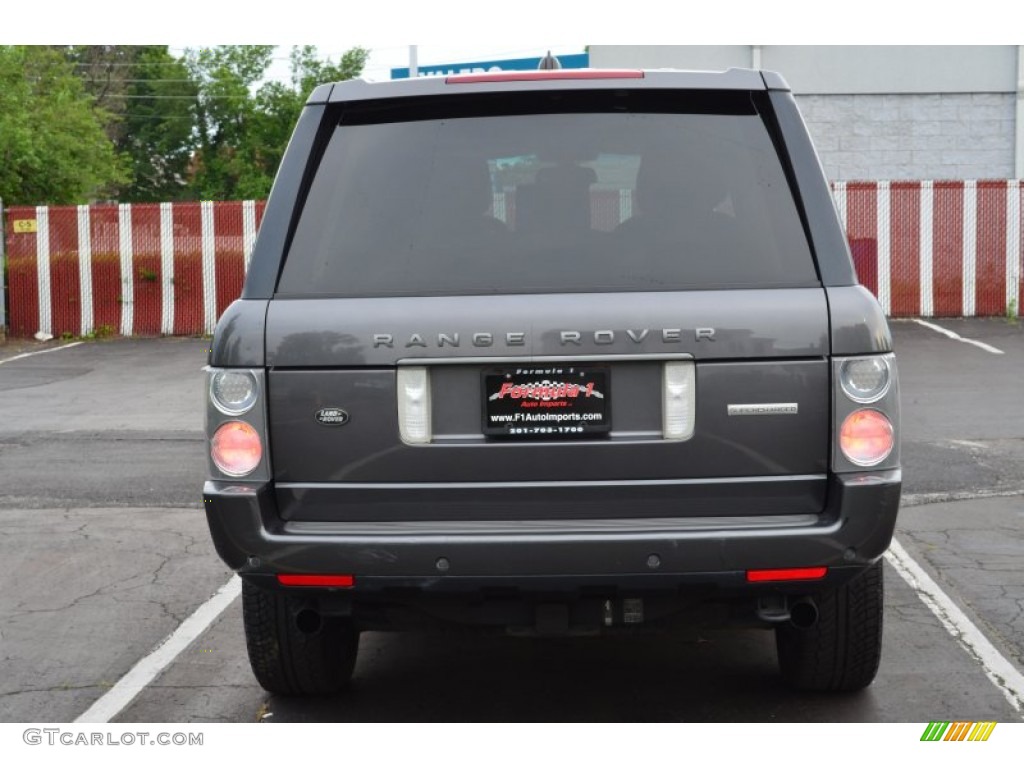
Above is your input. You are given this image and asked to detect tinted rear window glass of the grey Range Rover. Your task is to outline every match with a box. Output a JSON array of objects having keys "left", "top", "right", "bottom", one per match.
[{"left": 278, "top": 91, "right": 818, "bottom": 297}]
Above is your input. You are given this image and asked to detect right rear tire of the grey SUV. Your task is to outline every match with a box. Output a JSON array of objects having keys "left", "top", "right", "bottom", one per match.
[{"left": 775, "top": 560, "right": 885, "bottom": 691}]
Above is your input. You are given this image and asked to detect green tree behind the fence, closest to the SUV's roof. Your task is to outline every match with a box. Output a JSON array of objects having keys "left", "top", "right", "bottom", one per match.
[{"left": 187, "top": 45, "right": 369, "bottom": 200}]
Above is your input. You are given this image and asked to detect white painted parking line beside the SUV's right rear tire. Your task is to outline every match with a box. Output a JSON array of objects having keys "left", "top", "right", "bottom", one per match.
[{"left": 886, "top": 539, "right": 1024, "bottom": 712}]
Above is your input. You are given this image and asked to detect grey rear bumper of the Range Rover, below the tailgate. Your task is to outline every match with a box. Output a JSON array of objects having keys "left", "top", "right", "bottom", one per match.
[{"left": 204, "top": 469, "right": 901, "bottom": 593}]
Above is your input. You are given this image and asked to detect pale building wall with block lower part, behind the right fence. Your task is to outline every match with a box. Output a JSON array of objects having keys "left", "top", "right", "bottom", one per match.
[{"left": 590, "top": 45, "right": 1024, "bottom": 180}]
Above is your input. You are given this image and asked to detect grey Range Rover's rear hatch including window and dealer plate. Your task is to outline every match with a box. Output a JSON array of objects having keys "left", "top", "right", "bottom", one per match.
[{"left": 260, "top": 91, "right": 829, "bottom": 521}]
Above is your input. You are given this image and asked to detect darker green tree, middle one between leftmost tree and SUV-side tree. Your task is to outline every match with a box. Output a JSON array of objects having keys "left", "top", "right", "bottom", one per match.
[{"left": 65, "top": 45, "right": 199, "bottom": 202}]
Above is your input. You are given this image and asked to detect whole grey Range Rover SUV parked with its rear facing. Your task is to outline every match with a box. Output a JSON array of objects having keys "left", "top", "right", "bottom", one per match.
[{"left": 204, "top": 70, "right": 901, "bottom": 694}]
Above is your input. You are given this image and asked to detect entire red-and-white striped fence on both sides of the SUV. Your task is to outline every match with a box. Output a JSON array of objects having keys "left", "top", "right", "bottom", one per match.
[{"left": 5, "top": 180, "right": 1024, "bottom": 337}]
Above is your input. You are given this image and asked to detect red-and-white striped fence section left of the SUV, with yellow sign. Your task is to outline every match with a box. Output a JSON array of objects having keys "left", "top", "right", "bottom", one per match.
[{"left": 5, "top": 201, "right": 264, "bottom": 338}]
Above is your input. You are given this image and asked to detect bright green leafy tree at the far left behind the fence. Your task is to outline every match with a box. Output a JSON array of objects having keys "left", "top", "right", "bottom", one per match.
[{"left": 0, "top": 45, "right": 129, "bottom": 205}]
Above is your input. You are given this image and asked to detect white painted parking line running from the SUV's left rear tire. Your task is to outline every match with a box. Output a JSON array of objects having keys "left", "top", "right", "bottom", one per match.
[{"left": 75, "top": 575, "right": 242, "bottom": 723}]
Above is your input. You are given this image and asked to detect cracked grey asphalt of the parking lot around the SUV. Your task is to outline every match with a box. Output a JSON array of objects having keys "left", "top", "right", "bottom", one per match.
[{"left": 0, "top": 319, "right": 1024, "bottom": 723}]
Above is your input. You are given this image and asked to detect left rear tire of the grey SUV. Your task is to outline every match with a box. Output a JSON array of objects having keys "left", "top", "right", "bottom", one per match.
[{"left": 242, "top": 581, "right": 359, "bottom": 696}]
